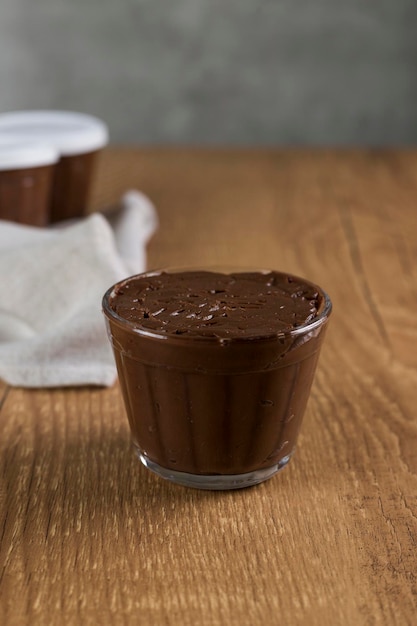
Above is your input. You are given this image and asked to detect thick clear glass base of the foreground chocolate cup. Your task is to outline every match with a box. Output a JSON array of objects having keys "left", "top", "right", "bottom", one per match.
[{"left": 137, "top": 451, "right": 291, "bottom": 491}]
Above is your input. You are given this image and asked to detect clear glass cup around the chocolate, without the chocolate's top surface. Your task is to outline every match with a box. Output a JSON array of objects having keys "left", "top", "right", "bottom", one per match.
[{"left": 103, "top": 270, "right": 332, "bottom": 489}]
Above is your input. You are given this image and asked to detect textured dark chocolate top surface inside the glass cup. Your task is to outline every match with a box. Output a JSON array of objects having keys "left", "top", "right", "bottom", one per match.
[{"left": 110, "top": 271, "right": 322, "bottom": 338}]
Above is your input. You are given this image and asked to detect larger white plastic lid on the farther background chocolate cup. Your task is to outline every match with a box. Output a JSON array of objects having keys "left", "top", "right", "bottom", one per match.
[{"left": 0, "top": 111, "right": 109, "bottom": 156}]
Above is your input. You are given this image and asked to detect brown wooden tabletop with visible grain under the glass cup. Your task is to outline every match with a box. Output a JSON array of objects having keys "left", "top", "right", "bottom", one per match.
[{"left": 0, "top": 149, "right": 417, "bottom": 626}]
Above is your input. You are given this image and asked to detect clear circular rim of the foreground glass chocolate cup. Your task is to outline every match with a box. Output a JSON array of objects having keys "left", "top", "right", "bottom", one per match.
[{"left": 102, "top": 266, "right": 333, "bottom": 344}]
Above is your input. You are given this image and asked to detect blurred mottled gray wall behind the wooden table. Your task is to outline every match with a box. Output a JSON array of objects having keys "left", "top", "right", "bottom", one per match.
[{"left": 0, "top": 0, "right": 417, "bottom": 145}]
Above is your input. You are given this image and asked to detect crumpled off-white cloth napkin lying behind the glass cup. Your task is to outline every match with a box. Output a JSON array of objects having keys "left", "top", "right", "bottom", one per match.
[{"left": 0, "top": 191, "right": 157, "bottom": 387}]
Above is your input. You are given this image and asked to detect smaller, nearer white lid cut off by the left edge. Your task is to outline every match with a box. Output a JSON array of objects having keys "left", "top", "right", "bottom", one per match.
[{"left": 0, "top": 139, "right": 59, "bottom": 171}]
